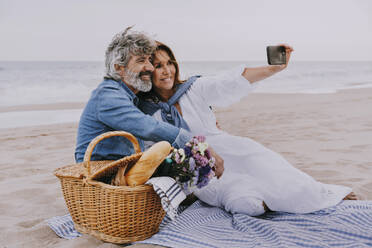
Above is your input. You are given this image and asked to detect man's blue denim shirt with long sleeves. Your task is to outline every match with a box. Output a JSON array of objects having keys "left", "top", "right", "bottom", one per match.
[{"left": 75, "top": 79, "right": 192, "bottom": 162}]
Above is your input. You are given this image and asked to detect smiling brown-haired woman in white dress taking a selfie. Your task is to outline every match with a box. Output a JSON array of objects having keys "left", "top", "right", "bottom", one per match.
[{"left": 140, "top": 43, "right": 356, "bottom": 216}]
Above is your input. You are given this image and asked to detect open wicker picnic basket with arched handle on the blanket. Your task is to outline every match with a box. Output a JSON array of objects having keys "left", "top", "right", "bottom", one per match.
[{"left": 55, "top": 131, "right": 165, "bottom": 244}]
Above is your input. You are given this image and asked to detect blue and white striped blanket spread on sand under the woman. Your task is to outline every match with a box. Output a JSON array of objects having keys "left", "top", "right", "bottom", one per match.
[{"left": 48, "top": 201, "right": 372, "bottom": 248}]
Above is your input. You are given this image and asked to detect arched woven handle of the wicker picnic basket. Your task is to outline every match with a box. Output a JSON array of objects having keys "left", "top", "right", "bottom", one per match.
[{"left": 84, "top": 131, "right": 141, "bottom": 177}]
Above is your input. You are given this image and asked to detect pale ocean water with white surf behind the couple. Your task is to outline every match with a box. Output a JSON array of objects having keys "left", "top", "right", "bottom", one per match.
[{"left": 0, "top": 61, "right": 372, "bottom": 128}]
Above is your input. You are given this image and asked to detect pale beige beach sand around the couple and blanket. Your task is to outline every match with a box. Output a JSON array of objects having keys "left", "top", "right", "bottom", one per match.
[{"left": 0, "top": 89, "right": 372, "bottom": 248}]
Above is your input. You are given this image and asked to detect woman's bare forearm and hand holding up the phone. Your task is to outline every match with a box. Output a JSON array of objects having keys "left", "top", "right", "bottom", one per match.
[{"left": 242, "top": 44, "right": 293, "bottom": 83}]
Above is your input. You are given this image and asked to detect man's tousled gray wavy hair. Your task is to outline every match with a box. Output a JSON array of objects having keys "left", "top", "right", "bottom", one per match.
[{"left": 105, "top": 27, "right": 156, "bottom": 81}]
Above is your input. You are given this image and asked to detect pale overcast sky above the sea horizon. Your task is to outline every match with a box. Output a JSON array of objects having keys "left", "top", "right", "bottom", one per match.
[{"left": 0, "top": 0, "right": 372, "bottom": 61}]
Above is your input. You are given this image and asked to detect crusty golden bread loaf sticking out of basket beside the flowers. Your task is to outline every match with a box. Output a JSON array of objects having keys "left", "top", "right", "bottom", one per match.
[{"left": 125, "top": 141, "right": 172, "bottom": 186}]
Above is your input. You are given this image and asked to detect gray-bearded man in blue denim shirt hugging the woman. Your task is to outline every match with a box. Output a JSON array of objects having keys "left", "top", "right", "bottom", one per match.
[{"left": 75, "top": 27, "right": 223, "bottom": 176}]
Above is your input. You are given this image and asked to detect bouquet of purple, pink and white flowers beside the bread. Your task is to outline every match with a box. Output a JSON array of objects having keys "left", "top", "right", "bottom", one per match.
[{"left": 164, "top": 136, "right": 216, "bottom": 194}]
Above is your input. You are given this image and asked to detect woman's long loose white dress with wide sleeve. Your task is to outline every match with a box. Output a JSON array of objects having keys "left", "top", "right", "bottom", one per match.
[{"left": 146, "top": 66, "right": 351, "bottom": 216}]
